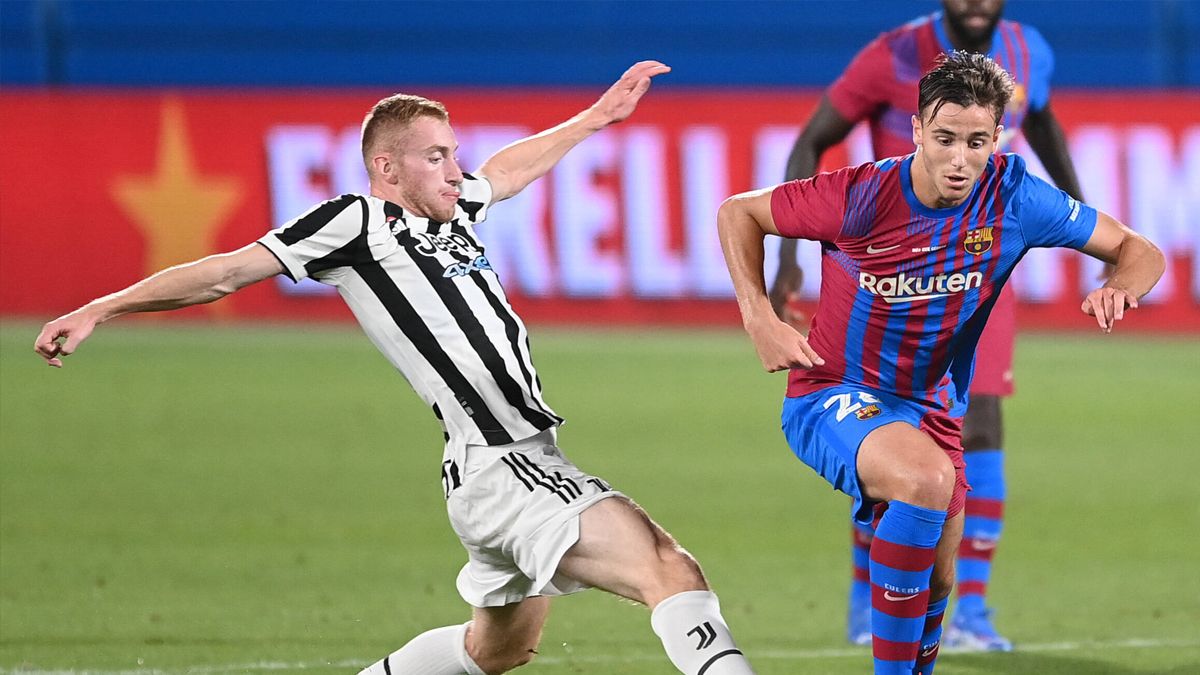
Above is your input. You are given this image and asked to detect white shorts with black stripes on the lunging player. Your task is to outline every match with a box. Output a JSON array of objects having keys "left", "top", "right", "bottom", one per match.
[{"left": 443, "top": 429, "right": 620, "bottom": 607}]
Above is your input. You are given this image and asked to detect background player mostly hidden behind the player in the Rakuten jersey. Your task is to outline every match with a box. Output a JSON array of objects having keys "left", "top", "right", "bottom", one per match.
[{"left": 770, "top": 0, "right": 1082, "bottom": 651}]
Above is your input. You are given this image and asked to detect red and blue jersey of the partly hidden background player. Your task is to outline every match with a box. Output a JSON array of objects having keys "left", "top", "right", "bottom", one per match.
[{"left": 827, "top": 12, "right": 1054, "bottom": 157}]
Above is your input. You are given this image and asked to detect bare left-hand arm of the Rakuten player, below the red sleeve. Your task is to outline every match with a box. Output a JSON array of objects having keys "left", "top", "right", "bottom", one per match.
[{"left": 716, "top": 187, "right": 824, "bottom": 372}]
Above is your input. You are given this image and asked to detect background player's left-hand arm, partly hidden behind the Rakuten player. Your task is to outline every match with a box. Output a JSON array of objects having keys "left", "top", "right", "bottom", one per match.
[{"left": 768, "top": 95, "right": 854, "bottom": 328}]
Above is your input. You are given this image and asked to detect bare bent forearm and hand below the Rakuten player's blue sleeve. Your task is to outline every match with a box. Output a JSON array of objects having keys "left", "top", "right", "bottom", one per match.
[{"left": 1080, "top": 211, "right": 1166, "bottom": 333}]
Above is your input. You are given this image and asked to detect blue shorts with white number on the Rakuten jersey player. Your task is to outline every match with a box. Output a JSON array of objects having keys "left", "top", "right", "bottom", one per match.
[{"left": 782, "top": 384, "right": 966, "bottom": 525}]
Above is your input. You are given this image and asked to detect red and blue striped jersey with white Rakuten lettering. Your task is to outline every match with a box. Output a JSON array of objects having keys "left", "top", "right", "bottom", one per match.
[{"left": 770, "top": 155, "right": 1096, "bottom": 411}]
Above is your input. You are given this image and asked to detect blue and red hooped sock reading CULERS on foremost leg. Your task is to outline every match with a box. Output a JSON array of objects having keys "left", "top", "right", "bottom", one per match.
[{"left": 871, "top": 501, "right": 946, "bottom": 675}]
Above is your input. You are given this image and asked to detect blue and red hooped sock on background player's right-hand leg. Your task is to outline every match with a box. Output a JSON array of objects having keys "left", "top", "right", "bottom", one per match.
[{"left": 955, "top": 449, "right": 1007, "bottom": 614}]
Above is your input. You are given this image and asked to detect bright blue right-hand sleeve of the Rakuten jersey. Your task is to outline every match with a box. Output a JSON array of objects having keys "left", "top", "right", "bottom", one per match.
[{"left": 1009, "top": 155, "right": 1096, "bottom": 249}]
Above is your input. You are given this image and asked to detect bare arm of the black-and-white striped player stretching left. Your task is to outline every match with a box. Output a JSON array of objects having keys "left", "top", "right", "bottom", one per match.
[{"left": 34, "top": 244, "right": 283, "bottom": 368}]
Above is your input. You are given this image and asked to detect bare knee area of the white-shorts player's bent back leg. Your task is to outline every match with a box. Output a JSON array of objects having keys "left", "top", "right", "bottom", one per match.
[{"left": 467, "top": 596, "right": 550, "bottom": 670}]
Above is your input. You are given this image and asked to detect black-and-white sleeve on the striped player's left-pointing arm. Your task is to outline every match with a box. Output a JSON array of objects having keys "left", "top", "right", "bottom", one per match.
[{"left": 258, "top": 195, "right": 370, "bottom": 281}]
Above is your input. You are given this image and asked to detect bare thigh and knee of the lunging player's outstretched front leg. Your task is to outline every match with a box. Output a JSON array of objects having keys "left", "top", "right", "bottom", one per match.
[{"left": 558, "top": 496, "right": 708, "bottom": 607}]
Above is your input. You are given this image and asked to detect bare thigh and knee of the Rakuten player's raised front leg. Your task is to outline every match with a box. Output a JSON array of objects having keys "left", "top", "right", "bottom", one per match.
[{"left": 858, "top": 422, "right": 955, "bottom": 510}]
